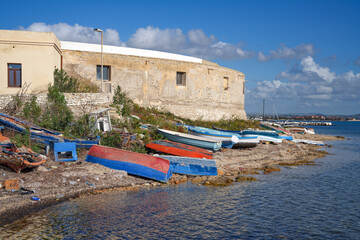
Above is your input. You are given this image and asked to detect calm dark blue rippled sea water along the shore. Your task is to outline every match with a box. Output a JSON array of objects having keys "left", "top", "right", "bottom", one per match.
[{"left": 0, "top": 122, "right": 360, "bottom": 239}]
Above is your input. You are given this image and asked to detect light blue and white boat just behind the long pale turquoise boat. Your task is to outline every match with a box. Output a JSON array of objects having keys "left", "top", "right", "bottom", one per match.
[{"left": 187, "top": 126, "right": 239, "bottom": 148}]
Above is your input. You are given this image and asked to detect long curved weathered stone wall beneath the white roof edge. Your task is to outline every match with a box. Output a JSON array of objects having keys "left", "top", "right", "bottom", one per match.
[{"left": 63, "top": 50, "right": 246, "bottom": 120}]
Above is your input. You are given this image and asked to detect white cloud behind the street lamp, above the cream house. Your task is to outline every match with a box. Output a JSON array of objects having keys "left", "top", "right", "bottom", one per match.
[{"left": 20, "top": 22, "right": 124, "bottom": 46}]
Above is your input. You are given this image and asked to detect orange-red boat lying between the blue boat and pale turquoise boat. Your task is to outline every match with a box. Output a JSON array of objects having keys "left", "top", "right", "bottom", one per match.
[{"left": 146, "top": 140, "right": 213, "bottom": 159}]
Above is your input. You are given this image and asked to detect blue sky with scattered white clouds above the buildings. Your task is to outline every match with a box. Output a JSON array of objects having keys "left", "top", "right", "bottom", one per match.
[{"left": 0, "top": 0, "right": 360, "bottom": 114}]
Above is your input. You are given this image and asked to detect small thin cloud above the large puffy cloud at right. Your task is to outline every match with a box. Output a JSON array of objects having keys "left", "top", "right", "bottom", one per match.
[{"left": 257, "top": 44, "right": 314, "bottom": 62}]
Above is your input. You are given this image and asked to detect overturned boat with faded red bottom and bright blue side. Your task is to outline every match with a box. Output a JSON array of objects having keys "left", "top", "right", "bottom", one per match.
[{"left": 86, "top": 145, "right": 172, "bottom": 182}]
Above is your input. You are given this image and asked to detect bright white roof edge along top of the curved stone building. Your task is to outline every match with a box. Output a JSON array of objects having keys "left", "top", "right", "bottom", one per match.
[{"left": 60, "top": 41, "right": 202, "bottom": 63}]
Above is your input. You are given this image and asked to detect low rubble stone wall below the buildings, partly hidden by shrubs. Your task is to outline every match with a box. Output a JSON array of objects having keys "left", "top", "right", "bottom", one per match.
[{"left": 0, "top": 93, "right": 112, "bottom": 116}]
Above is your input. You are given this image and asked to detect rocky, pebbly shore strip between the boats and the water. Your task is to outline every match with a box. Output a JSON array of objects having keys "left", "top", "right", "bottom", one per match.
[{"left": 0, "top": 135, "right": 344, "bottom": 226}]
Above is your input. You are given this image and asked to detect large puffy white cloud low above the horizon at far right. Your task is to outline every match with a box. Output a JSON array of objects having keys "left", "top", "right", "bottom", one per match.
[{"left": 248, "top": 56, "right": 360, "bottom": 103}]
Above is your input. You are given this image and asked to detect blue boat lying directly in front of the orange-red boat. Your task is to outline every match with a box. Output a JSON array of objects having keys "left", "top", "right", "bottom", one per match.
[{"left": 159, "top": 155, "right": 217, "bottom": 176}]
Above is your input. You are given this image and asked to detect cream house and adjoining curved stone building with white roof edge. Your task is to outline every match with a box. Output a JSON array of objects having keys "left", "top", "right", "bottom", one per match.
[{"left": 0, "top": 30, "right": 246, "bottom": 120}]
